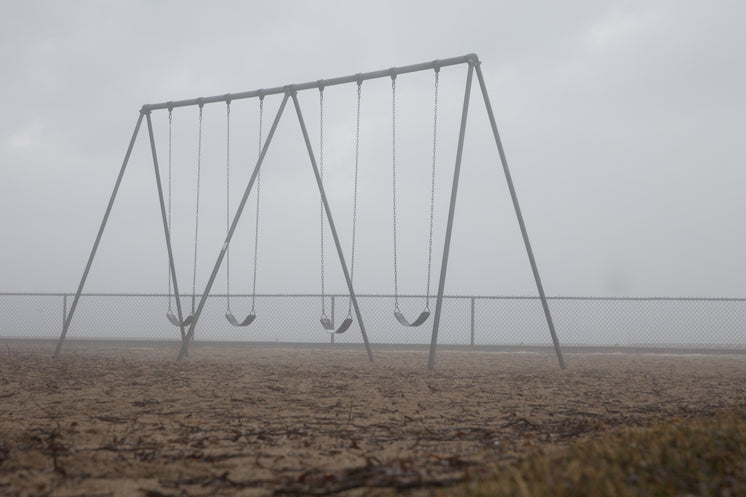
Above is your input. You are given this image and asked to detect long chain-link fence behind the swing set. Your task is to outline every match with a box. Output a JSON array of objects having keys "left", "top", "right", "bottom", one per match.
[{"left": 0, "top": 293, "right": 746, "bottom": 350}]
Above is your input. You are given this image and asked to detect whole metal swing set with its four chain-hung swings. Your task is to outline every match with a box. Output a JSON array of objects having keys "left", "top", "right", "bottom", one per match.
[{"left": 54, "top": 54, "right": 565, "bottom": 369}]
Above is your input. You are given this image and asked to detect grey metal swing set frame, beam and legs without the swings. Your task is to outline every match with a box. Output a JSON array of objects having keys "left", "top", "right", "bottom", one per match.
[{"left": 54, "top": 53, "right": 566, "bottom": 369}]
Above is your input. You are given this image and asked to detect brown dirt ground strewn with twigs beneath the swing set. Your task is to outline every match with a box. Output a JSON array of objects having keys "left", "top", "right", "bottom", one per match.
[{"left": 0, "top": 342, "right": 746, "bottom": 497}]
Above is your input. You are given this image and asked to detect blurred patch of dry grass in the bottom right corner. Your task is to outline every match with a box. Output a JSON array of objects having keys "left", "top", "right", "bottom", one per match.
[{"left": 448, "top": 411, "right": 746, "bottom": 497}]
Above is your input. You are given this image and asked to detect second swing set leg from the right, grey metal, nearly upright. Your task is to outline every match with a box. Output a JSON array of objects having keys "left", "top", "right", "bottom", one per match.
[{"left": 427, "top": 60, "right": 474, "bottom": 369}]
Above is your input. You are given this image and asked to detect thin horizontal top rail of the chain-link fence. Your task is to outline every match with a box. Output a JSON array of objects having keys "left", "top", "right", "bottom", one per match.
[{"left": 0, "top": 292, "right": 746, "bottom": 302}]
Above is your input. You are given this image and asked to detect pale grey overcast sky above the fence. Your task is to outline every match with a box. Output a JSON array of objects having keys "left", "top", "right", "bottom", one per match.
[{"left": 0, "top": 0, "right": 746, "bottom": 297}]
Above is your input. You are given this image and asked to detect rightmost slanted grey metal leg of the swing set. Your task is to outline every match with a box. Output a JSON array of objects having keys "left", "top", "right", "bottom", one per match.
[{"left": 475, "top": 61, "right": 566, "bottom": 369}]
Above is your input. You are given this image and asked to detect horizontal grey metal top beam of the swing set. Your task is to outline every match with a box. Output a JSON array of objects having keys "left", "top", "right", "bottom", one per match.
[{"left": 140, "top": 53, "right": 479, "bottom": 113}]
